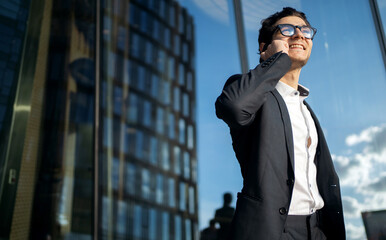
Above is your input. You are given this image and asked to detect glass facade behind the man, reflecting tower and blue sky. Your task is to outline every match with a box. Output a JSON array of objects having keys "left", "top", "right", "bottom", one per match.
[{"left": 0, "top": 0, "right": 386, "bottom": 240}]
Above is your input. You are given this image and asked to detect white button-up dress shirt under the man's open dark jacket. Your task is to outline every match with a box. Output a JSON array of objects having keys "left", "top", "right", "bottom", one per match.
[{"left": 276, "top": 81, "right": 324, "bottom": 215}]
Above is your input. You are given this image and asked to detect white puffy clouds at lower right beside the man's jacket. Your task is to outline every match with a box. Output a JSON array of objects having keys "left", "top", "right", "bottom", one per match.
[{"left": 332, "top": 124, "right": 386, "bottom": 240}]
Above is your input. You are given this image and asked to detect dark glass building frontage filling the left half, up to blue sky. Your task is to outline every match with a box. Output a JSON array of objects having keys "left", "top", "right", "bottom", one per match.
[{"left": 0, "top": 0, "right": 198, "bottom": 240}]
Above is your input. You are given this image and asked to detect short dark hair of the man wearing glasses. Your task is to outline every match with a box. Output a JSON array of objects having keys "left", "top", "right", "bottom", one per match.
[{"left": 259, "top": 7, "right": 311, "bottom": 52}]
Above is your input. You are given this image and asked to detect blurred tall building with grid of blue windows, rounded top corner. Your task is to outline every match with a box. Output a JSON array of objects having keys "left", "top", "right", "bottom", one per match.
[{"left": 100, "top": 1, "right": 198, "bottom": 240}]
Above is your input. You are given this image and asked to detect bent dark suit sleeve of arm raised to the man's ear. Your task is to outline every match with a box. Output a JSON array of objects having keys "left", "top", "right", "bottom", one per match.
[{"left": 215, "top": 52, "right": 291, "bottom": 128}]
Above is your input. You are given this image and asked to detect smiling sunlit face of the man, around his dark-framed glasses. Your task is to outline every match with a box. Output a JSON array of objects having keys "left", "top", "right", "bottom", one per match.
[{"left": 272, "top": 16, "right": 312, "bottom": 67}]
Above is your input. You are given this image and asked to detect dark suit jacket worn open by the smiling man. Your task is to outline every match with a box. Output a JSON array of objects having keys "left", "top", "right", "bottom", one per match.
[{"left": 216, "top": 52, "right": 345, "bottom": 240}]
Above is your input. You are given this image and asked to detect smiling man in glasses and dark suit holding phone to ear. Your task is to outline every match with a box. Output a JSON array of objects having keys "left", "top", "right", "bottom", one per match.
[{"left": 216, "top": 8, "right": 345, "bottom": 240}]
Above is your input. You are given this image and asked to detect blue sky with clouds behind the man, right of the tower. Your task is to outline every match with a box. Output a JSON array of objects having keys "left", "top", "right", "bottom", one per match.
[{"left": 179, "top": 0, "right": 386, "bottom": 240}]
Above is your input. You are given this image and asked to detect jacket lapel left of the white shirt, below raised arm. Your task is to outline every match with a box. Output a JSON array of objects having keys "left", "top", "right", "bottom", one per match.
[{"left": 272, "top": 89, "right": 295, "bottom": 169}]
